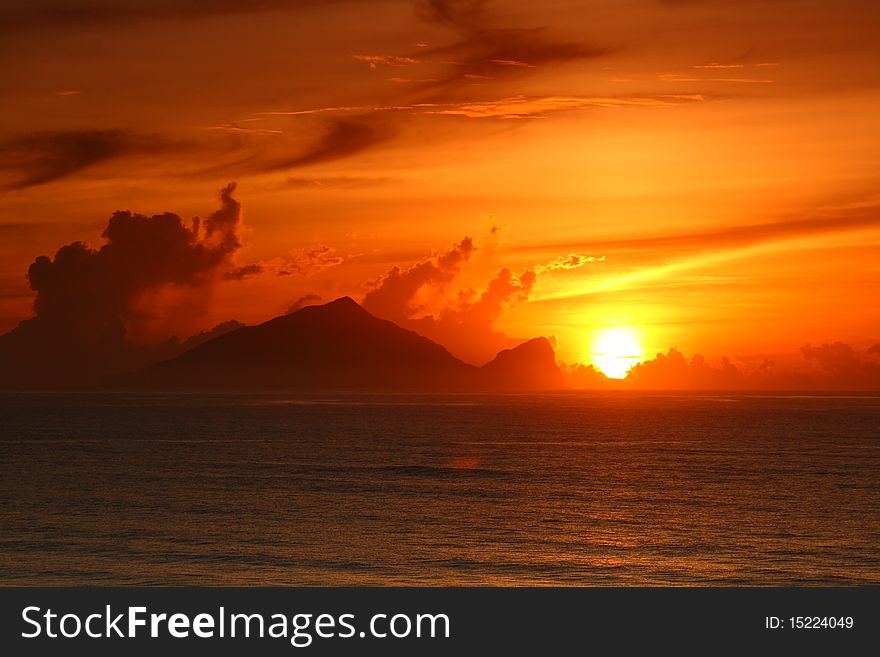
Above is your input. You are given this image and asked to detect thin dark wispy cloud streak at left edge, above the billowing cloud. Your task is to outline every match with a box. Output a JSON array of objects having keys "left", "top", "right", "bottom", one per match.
[{"left": 0, "top": 130, "right": 158, "bottom": 190}]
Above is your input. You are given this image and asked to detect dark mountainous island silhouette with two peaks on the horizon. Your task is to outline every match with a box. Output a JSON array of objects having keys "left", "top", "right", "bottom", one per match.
[{"left": 117, "top": 297, "right": 563, "bottom": 391}]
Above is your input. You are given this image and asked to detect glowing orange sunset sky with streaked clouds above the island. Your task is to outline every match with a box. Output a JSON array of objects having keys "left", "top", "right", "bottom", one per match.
[{"left": 0, "top": 0, "right": 880, "bottom": 384}]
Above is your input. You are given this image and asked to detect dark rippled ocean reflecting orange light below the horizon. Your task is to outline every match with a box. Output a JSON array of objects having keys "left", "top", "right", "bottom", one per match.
[{"left": 0, "top": 392, "right": 880, "bottom": 586}]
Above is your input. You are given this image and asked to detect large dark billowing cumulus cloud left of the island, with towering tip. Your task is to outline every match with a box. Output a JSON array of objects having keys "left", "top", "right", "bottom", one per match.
[{"left": 0, "top": 183, "right": 242, "bottom": 386}]
